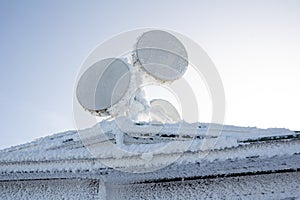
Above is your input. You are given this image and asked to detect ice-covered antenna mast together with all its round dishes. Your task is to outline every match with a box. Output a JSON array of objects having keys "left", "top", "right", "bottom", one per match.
[{"left": 76, "top": 30, "right": 188, "bottom": 121}]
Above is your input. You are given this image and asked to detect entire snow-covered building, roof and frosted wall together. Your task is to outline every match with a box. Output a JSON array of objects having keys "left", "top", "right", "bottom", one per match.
[{"left": 0, "top": 118, "right": 300, "bottom": 200}]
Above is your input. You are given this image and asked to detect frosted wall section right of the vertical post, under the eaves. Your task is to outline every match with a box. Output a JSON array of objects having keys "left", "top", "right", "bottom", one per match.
[{"left": 107, "top": 172, "right": 300, "bottom": 200}]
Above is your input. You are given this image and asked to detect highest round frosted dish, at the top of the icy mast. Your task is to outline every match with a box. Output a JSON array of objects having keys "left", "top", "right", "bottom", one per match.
[{"left": 136, "top": 30, "right": 188, "bottom": 81}]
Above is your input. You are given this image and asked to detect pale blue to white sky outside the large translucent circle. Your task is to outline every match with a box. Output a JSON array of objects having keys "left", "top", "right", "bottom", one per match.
[{"left": 0, "top": 0, "right": 300, "bottom": 148}]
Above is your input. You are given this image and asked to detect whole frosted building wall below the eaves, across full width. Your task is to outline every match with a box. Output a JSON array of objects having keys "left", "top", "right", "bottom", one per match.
[{"left": 0, "top": 172, "right": 300, "bottom": 200}]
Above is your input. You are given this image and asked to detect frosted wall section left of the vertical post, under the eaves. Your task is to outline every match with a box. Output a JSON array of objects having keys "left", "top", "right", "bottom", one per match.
[{"left": 0, "top": 179, "right": 99, "bottom": 200}]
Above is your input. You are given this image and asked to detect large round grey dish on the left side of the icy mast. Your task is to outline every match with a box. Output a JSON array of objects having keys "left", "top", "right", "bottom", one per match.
[{"left": 76, "top": 58, "right": 131, "bottom": 112}]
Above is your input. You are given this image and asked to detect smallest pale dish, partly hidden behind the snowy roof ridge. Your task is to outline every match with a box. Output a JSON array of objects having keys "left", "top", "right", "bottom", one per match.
[{"left": 150, "top": 99, "right": 180, "bottom": 123}]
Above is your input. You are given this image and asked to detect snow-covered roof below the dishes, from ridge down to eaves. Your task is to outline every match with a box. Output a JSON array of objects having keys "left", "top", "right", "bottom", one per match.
[{"left": 0, "top": 120, "right": 300, "bottom": 182}]
